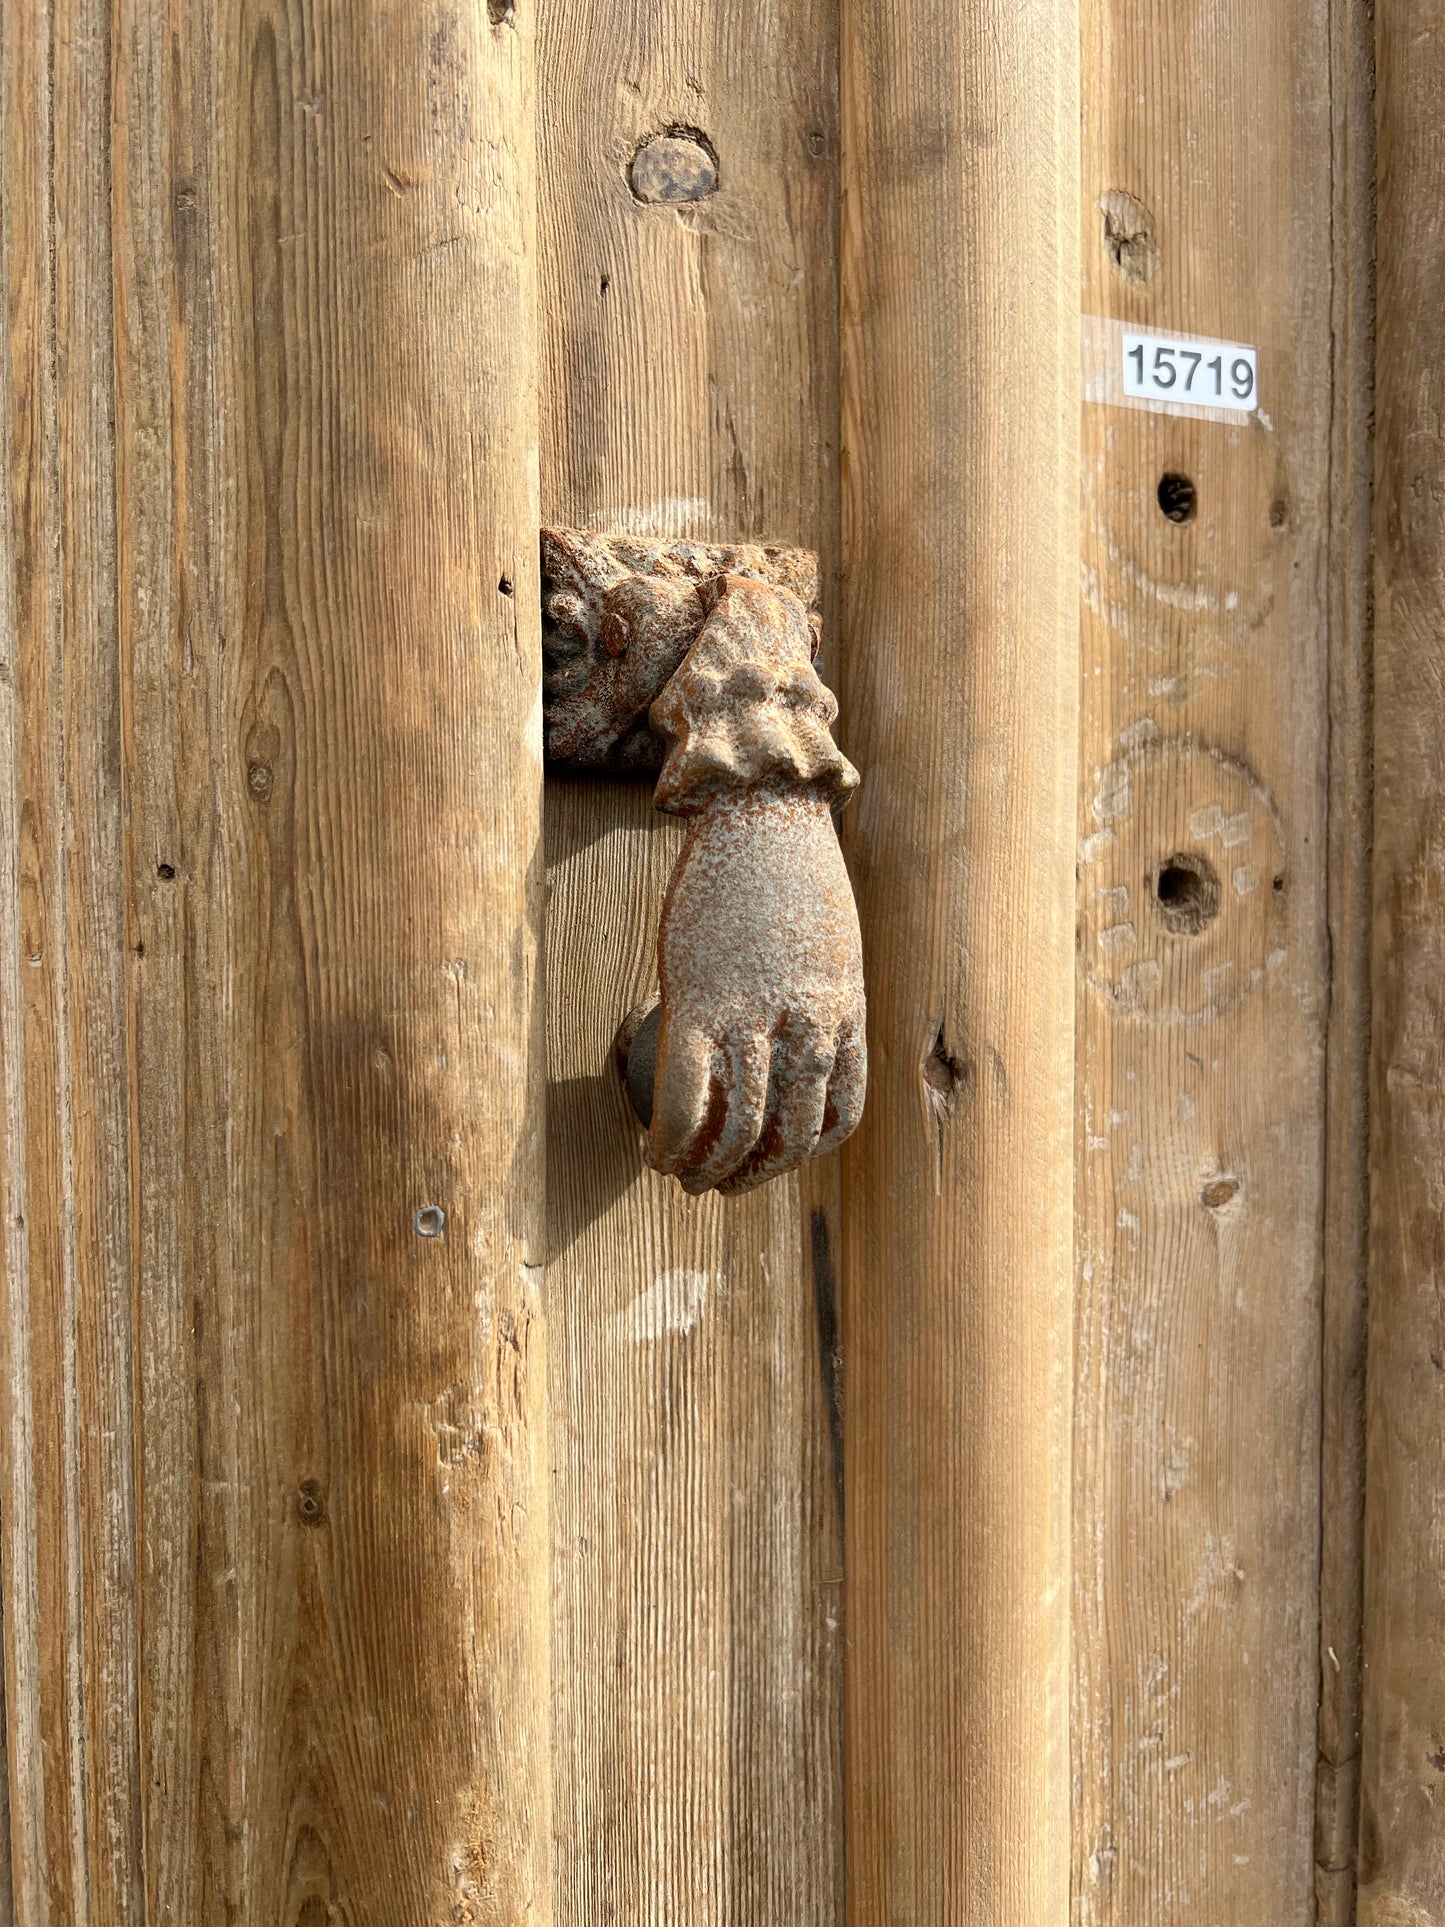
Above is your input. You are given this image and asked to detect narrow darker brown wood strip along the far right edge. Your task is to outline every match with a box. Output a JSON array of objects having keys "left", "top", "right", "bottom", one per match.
[{"left": 1358, "top": 0, "right": 1445, "bottom": 1927}]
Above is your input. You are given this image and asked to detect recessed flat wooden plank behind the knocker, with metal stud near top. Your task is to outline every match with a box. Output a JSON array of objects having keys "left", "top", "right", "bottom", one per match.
[{"left": 539, "top": 0, "right": 842, "bottom": 1927}]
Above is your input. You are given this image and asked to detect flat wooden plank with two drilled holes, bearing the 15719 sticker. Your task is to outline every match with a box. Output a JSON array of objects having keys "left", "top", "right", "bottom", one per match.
[{"left": 1073, "top": 0, "right": 1333, "bottom": 1927}]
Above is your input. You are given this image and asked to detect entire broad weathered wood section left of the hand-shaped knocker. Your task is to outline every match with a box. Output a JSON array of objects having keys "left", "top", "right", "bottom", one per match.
[{"left": 0, "top": 0, "right": 551, "bottom": 1927}]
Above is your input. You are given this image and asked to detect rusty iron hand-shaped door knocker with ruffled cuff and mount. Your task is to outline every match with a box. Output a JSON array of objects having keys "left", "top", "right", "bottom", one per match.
[{"left": 541, "top": 528, "right": 867, "bottom": 1191}]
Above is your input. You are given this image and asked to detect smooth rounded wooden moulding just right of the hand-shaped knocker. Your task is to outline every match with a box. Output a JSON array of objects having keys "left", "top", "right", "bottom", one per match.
[{"left": 840, "top": 0, "right": 1079, "bottom": 1927}]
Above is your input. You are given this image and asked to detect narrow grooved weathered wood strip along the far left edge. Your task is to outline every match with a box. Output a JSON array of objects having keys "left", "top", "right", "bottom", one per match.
[{"left": 0, "top": 0, "right": 143, "bottom": 1923}]
